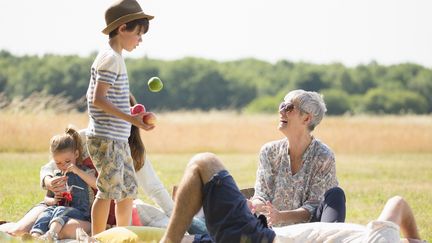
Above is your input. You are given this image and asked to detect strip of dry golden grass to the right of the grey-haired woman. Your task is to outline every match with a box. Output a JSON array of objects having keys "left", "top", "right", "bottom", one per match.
[{"left": 316, "top": 116, "right": 432, "bottom": 153}]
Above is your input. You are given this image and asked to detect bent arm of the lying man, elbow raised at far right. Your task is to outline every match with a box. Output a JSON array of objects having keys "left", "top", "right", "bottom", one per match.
[{"left": 378, "top": 196, "right": 420, "bottom": 242}]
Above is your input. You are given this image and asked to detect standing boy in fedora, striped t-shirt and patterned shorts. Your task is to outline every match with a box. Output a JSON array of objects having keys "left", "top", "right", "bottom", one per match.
[{"left": 86, "top": 0, "right": 154, "bottom": 235}]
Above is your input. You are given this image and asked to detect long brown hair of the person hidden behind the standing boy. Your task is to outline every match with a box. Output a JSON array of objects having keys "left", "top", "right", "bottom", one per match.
[{"left": 128, "top": 93, "right": 146, "bottom": 171}]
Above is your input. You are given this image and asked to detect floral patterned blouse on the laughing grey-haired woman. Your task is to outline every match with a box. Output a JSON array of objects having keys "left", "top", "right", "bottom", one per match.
[{"left": 254, "top": 138, "right": 338, "bottom": 224}]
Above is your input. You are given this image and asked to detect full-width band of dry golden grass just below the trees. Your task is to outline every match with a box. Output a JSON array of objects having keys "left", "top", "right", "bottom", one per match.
[{"left": 0, "top": 112, "right": 432, "bottom": 153}]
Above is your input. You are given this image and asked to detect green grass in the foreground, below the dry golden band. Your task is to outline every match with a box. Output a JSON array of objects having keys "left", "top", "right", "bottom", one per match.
[{"left": 0, "top": 153, "right": 432, "bottom": 241}]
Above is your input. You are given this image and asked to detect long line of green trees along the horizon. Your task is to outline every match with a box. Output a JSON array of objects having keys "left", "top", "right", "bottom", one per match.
[{"left": 0, "top": 50, "right": 432, "bottom": 115}]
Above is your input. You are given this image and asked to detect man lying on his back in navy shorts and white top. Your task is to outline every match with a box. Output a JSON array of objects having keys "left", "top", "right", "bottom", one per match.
[{"left": 161, "top": 153, "right": 424, "bottom": 243}]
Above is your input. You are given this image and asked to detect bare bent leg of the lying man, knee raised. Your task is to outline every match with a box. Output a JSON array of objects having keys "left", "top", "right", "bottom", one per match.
[{"left": 161, "top": 153, "right": 225, "bottom": 243}]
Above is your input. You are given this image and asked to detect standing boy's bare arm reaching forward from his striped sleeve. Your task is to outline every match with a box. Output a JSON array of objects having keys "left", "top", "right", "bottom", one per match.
[{"left": 92, "top": 82, "right": 154, "bottom": 131}]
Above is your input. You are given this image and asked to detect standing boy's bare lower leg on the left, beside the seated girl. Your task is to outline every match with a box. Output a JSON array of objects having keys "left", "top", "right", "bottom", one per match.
[{"left": 91, "top": 198, "right": 111, "bottom": 235}]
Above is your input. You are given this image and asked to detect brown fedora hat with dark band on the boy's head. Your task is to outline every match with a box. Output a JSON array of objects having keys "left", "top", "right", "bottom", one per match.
[{"left": 102, "top": 0, "right": 154, "bottom": 35}]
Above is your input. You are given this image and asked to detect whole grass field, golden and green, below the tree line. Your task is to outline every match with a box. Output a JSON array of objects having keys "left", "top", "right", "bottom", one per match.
[{"left": 0, "top": 113, "right": 432, "bottom": 241}]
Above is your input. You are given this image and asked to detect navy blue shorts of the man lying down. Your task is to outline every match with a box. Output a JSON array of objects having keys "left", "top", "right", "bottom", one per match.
[{"left": 194, "top": 170, "right": 276, "bottom": 243}]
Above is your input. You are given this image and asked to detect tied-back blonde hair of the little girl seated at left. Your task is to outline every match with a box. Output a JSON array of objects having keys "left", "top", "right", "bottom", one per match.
[{"left": 50, "top": 125, "right": 82, "bottom": 164}]
